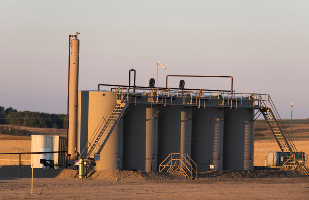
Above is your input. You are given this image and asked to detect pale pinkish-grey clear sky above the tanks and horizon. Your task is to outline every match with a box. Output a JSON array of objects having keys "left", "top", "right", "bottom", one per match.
[{"left": 0, "top": 0, "right": 309, "bottom": 118}]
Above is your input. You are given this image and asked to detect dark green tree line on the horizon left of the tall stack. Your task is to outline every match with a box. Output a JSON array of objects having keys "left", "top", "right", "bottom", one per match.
[{"left": 0, "top": 106, "right": 67, "bottom": 128}]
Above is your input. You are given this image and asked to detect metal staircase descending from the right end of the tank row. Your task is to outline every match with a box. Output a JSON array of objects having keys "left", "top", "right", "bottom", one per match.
[{"left": 260, "top": 96, "right": 304, "bottom": 168}]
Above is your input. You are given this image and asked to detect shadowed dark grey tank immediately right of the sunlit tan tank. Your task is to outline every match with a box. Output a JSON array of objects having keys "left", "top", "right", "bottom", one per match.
[{"left": 123, "top": 105, "right": 146, "bottom": 171}]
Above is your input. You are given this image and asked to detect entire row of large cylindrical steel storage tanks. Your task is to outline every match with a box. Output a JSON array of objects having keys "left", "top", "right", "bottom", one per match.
[{"left": 77, "top": 91, "right": 254, "bottom": 172}]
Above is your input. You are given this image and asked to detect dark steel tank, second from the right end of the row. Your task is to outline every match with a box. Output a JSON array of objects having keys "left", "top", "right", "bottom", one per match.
[{"left": 191, "top": 107, "right": 224, "bottom": 172}]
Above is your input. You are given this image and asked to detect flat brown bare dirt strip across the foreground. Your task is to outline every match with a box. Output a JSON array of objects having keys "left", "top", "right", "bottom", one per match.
[{"left": 0, "top": 178, "right": 309, "bottom": 199}]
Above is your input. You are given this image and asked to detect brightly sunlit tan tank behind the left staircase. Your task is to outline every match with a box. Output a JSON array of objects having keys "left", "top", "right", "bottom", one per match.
[{"left": 86, "top": 91, "right": 123, "bottom": 170}]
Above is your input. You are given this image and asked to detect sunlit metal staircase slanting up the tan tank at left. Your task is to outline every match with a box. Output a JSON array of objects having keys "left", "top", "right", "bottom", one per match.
[{"left": 80, "top": 94, "right": 128, "bottom": 159}]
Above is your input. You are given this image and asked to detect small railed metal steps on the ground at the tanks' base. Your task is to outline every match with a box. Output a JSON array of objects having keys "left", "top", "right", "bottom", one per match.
[{"left": 159, "top": 153, "right": 198, "bottom": 180}]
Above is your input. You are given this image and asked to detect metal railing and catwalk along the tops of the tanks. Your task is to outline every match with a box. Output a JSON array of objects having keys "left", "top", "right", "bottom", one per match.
[{"left": 106, "top": 87, "right": 272, "bottom": 108}]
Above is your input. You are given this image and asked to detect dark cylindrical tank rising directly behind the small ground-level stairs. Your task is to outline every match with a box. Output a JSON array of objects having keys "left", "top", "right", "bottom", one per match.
[{"left": 158, "top": 106, "right": 192, "bottom": 165}]
